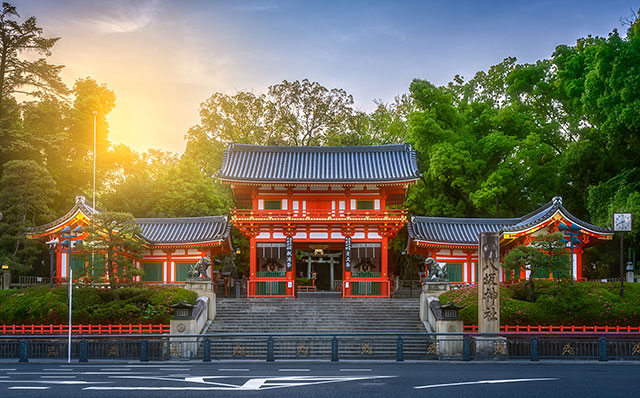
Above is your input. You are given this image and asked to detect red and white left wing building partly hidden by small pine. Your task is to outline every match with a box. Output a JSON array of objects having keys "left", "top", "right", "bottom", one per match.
[{"left": 28, "top": 196, "right": 231, "bottom": 284}]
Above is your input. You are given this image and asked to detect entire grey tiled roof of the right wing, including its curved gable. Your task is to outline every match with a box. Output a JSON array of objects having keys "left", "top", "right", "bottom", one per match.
[{"left": 408, "top": 196, "right": 611, "bottom": 244}]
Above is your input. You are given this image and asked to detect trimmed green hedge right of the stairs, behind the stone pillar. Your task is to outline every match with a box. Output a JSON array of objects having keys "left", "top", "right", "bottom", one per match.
[{"left": 440, "top": 281, "right": 640, "bottom": 326}]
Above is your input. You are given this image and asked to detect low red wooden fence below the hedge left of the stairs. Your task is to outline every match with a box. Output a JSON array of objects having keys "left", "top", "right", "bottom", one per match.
[{"left": 0, "top": 324, "right": 169, "bottom": 334}]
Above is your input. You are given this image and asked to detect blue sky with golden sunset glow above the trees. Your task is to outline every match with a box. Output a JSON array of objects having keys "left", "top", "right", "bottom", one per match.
[{"left": 13, "top": 0, "right": 640, "bottom": 152}]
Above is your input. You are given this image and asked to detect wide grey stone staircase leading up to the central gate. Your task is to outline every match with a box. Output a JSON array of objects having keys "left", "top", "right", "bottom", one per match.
[{"left": 201, "top": 293, "right": 430, "bottom": 359}]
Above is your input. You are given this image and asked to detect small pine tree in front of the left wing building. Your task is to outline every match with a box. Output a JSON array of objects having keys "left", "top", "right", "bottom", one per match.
[{"left": 85, "top": 212, "right": 143, "bottom": 299}]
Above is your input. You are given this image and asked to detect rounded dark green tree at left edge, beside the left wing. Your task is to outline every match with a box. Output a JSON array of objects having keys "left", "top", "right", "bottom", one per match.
[{"left": 0, "top": 160, "right": 56, "bottom": 272}]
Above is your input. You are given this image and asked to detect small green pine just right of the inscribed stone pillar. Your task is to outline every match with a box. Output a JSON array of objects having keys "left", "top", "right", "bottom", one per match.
[{"left": 502, "top": 232, "right": 571, "bottom": 300}]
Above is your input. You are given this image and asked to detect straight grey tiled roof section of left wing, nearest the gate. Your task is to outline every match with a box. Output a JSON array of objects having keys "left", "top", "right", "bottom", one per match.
[{"left": 136, "top": 216, "right": 231, "bottom": 244}]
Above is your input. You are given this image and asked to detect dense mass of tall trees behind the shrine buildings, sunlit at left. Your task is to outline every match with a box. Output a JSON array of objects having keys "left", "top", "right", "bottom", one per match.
[{"left": 0, "top": 4, "right": 640, "bottom": 272}]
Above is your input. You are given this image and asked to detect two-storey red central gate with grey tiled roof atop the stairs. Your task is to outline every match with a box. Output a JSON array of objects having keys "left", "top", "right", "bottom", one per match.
[{"left": 218, "top": 144, "right": 420, "bottom": 297}]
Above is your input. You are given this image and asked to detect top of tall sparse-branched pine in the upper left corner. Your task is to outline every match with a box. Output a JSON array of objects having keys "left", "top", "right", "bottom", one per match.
[{"left": 0, "top": 2, "right": 67, "bottom": 119}]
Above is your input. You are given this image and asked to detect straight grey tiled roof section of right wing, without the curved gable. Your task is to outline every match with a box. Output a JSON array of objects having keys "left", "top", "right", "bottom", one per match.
[{"left": 407, "top": 217, "right": 520, "bottom": 244}]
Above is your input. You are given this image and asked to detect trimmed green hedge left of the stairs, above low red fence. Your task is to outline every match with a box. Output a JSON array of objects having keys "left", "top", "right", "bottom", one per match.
[{"left": 0, "top": 286, "right": 198, "bottom": 325}]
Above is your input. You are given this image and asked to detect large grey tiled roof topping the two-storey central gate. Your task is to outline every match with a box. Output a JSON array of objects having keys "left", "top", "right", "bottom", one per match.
[{"left": 218, "top": 144, "right": 420, "bottom": 183}]
